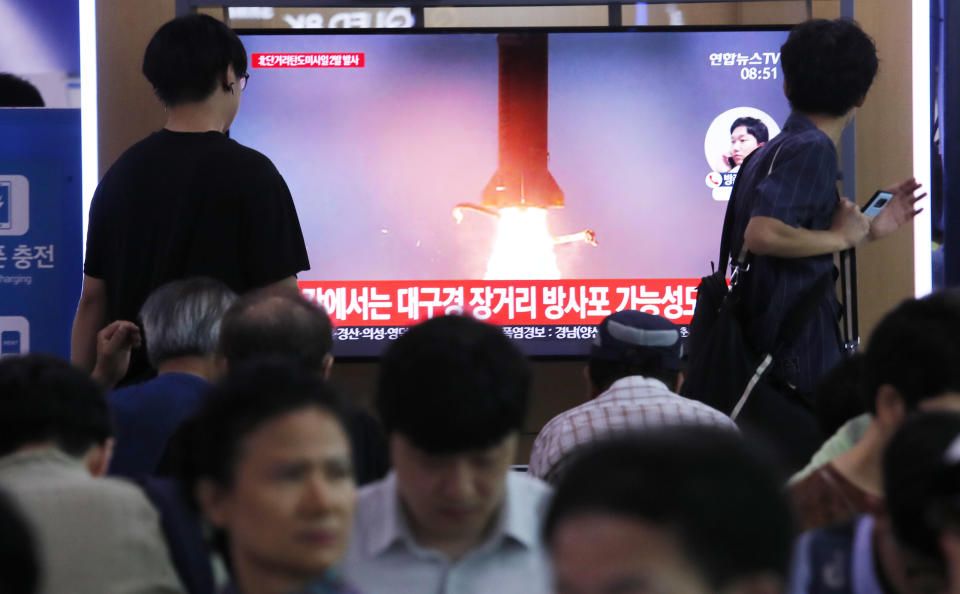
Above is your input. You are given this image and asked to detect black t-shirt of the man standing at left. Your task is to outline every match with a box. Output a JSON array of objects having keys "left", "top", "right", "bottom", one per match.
[{"left": 84, "top": 130, "right": 310, "bottom": 377}]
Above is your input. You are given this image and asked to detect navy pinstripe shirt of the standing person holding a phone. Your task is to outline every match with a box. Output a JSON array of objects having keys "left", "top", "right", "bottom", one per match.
[{"left": 730, "top": 113, "right": 842, "bottom": 394}]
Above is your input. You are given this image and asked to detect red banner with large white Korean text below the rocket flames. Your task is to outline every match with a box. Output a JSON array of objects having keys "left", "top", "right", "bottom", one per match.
[{"left": 299, "top": 278, "right": 700, "bottom": 326}]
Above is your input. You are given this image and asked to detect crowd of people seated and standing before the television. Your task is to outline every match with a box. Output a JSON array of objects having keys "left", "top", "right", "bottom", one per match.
[{"left": 0, "top": 10, "right": 960, "bottom": 594}]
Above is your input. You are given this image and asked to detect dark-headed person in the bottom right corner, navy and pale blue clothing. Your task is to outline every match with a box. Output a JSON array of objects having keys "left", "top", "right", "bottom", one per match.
[{"left": 788, "top": 412, "right": 960, "bottom": 594}]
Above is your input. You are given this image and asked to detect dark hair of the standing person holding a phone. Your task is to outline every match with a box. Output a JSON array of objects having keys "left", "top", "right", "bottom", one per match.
[{"left": 780, "top": 19, "right": 878, "bottom": 116}]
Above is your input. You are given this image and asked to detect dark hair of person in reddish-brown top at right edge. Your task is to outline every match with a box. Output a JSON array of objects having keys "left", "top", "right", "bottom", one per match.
[{"left": 863, "top": 289, "right": 960, "bottom": 413}]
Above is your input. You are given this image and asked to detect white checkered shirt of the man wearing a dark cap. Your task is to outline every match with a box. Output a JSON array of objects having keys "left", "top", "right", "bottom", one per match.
[{"left": 529, "top": 375, "right": 737, "bottom": 478}]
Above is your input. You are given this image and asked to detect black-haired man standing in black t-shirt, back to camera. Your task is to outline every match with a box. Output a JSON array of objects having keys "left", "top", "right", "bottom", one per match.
[{"left": 71, "top": 15, "right": 310, "bottom": 378}]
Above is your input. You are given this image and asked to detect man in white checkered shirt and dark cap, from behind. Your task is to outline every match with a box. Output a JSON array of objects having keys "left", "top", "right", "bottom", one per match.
[{"left": 529, "top": 310, "right": 737, "bottom": 482}]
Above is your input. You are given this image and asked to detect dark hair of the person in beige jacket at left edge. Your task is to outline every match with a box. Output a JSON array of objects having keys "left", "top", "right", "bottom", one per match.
[{"left": 0, "top": 354, "right": 111, "bottom": 456}]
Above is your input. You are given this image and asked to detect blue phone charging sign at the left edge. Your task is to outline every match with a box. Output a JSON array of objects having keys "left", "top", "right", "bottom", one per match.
[{"left": 0, "top": 108, "right": 83, "bottom": 358}]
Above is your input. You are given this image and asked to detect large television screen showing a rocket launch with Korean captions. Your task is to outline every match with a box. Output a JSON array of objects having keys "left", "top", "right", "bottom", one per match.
[{"left": 230, "top": 28, "right": 789, "bottom": 356}]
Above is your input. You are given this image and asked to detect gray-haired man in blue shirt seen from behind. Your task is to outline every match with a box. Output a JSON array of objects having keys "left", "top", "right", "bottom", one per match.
[{"left": 104, "top": 277, "right": 237, "bottom": 477}]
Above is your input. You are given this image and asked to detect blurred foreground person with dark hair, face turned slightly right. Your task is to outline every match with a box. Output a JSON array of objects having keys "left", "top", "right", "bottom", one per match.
[{"left": 179, "top": 360, "right": 356, "bottom": 594}]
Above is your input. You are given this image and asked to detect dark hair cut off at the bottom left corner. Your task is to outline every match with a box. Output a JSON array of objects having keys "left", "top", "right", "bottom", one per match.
[{"left": 0, "top": 491, "right": 40, "bottom": 594}]
